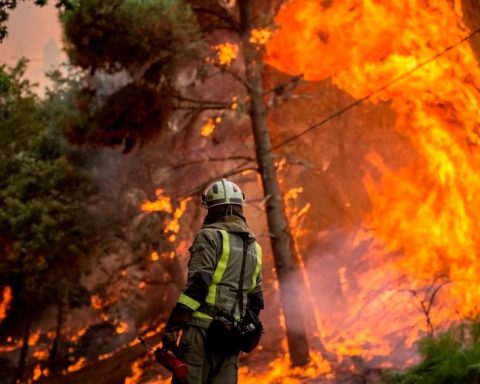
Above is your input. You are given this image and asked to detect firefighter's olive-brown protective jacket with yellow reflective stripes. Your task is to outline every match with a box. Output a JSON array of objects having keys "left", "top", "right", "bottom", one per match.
[{"left": 178, "top": 215, "right": 264, "bottom": 328}]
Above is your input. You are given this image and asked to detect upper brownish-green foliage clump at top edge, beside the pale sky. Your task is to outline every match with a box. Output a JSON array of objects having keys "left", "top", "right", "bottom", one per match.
[{"left": 62, "top": 0, "right": 197, "bottom": 73}]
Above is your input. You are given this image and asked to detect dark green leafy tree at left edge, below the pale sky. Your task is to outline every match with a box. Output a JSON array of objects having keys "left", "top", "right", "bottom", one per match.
[{"left": 0, "top": 61, "right": 92, "bottom": 324}]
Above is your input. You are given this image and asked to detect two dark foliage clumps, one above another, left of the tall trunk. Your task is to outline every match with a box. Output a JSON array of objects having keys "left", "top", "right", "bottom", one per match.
[{"left": 57, "top": 0, "right": 202, "bottom": 152}]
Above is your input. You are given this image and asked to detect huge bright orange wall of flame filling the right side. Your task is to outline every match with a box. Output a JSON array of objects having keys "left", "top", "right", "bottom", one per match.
[{"left": 266, "top": 0, "right": 480, "bottom": 368}]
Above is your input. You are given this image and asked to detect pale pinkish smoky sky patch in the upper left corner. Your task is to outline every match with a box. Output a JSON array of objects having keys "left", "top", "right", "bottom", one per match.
[{"left": 0, "top": 1, "right": 66, "bottom": 94}]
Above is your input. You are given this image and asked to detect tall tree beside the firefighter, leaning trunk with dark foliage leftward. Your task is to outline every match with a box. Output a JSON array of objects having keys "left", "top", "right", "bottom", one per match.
[{"left": 58, "top": 0, "right": 308, "bottom": 365}]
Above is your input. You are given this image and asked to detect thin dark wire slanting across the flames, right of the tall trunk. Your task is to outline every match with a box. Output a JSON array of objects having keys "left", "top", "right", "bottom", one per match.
[{"left": 268, "top": 28, "right": 480, "bottom": 155}]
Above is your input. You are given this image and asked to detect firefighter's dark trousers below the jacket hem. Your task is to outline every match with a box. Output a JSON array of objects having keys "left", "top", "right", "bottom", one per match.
[{"left": 172, "top": 325, "right": 238, "bottom": 384}]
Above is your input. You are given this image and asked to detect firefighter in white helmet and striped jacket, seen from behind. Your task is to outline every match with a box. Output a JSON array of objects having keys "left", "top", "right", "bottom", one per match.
[{"left": 162, "top": 179, "right": 264, "bottom": 384}]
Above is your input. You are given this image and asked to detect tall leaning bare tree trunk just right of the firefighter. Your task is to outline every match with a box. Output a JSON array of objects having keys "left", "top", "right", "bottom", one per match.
[{"left": 238, "top": 0, "right": 308, "bottom": 366}]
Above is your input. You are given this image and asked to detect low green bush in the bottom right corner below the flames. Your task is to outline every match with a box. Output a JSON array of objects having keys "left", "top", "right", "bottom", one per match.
[{"left": 387, "top": 318, "right": 480, "bottom": 384}]
